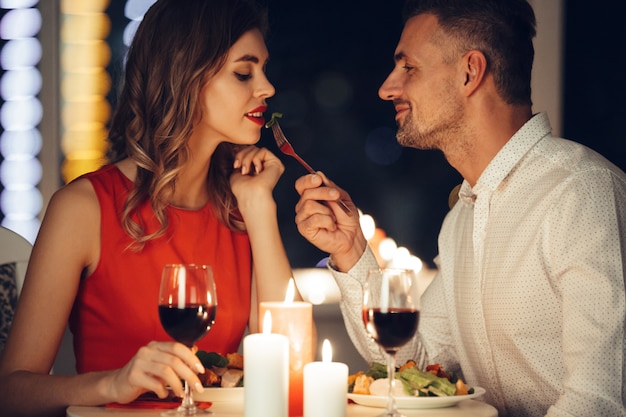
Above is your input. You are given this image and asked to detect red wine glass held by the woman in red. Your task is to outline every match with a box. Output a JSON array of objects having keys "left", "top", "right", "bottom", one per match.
[{"left": 159, "top": 264, "right": 217, "bottom": 416}]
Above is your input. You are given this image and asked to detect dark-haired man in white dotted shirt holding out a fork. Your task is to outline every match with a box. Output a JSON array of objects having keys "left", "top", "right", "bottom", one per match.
[{"left": 296, "top": 0, "right": 626, "bottom": 417}]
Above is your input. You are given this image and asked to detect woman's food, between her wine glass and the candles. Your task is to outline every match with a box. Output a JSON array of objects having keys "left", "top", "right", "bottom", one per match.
[{"left": 196, "top": 350, "right": 243, "bottom": 388}]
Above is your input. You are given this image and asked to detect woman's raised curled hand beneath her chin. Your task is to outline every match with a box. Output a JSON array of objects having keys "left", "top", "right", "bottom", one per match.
[{"left": 230, "top": 145, "right": 285, "bottom": 208}]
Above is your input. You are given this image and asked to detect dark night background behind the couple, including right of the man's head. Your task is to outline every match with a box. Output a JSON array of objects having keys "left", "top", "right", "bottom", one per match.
[{"left": 109, "top": 0, "right": 626, "bottom": 268}]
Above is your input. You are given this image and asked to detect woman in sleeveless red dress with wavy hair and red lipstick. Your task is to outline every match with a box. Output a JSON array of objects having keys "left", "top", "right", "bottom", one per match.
[{"left": 0, "top": 0, "right": 291, "bottom": 415}]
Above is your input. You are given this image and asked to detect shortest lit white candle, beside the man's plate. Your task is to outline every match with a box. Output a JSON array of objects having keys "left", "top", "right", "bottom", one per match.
[{"left": 304, "top": 339, "right": 348, "bottom": 417}]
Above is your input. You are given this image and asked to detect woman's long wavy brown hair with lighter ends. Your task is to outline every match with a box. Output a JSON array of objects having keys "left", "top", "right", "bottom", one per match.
[{"left": 108, "top": 0, "right": 267, "bottom": 248}]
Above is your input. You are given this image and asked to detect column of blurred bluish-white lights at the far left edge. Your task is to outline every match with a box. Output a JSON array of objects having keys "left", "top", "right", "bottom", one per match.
[{"left": 0, "top": 0, "right": 43, "bottom": 242}]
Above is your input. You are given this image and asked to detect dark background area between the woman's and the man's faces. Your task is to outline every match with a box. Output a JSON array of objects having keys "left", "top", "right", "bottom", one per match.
[{"left": 256, "top": 0, "right": 461, "bottom": 267}]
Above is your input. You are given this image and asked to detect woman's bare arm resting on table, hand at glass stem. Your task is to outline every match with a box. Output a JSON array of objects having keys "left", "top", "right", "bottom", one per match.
[{"left": 0, "top": 180, "right": 203, "bottom": 416}]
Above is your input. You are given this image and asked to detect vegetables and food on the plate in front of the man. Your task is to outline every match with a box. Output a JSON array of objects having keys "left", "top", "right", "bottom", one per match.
[{"left": 348, "top": 361, "right": 474, "bottom": 397}]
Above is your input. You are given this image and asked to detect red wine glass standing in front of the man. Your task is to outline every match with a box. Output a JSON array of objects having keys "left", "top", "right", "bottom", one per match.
[{"left": 363, "top": 268, "right": 419, "bottom": 417}]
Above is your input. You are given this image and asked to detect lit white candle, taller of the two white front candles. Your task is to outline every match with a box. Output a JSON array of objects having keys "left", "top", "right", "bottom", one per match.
[{"left": 243, "top": 311, "right": 289, "bottom": 417}]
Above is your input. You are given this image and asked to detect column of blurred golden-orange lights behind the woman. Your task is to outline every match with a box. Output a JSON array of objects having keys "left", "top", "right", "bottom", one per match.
[{"left": 61, "top": 0, "right": 111, "bottom": 182}]
